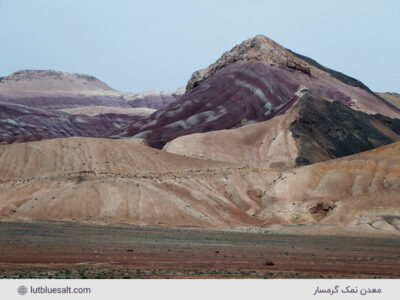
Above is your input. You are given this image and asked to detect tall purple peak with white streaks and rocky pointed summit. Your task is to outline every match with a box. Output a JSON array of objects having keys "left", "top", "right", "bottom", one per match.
[{"left": 108, "top": 36, "right": 400, "bottom": 148}]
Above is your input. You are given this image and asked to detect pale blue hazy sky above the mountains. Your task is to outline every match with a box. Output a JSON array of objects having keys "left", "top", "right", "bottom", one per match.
[{"left": 0, "top": 0, "right": 400, "bottom": 92}]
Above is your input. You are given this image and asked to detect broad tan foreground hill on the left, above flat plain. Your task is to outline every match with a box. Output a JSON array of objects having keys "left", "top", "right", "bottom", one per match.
[{"left": 0, "top": 138, "right": 258, "bottom": 226}]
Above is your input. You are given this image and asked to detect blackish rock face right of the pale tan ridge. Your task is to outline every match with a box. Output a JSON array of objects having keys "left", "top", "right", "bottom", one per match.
[{"left": 290, "top": 94, "right": 400, "bottom": 165}]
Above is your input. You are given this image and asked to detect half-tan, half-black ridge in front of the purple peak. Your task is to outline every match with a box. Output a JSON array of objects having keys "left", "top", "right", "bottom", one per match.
[{"left": 164, "top": 89, "right": 400, "bottom": 169}]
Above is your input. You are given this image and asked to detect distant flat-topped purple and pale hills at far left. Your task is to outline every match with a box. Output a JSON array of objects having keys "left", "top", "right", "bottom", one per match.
[{"left": 0, "top": 70, "right": 182, "bottom": 143}]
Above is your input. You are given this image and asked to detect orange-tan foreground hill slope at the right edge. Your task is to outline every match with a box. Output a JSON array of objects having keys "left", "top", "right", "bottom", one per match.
[{"left": 260, "top": 142, "right": 400, "bottom": 231}]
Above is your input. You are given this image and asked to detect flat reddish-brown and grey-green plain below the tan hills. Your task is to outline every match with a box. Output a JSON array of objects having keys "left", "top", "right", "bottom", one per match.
[{"left": 0, "top": 222, "right": 400, "bottom": 278}]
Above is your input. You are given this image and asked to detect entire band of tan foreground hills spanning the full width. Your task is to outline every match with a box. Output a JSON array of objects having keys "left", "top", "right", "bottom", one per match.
[{"left": 0, "top": 138, "right": 400, "bottom": 232}]
